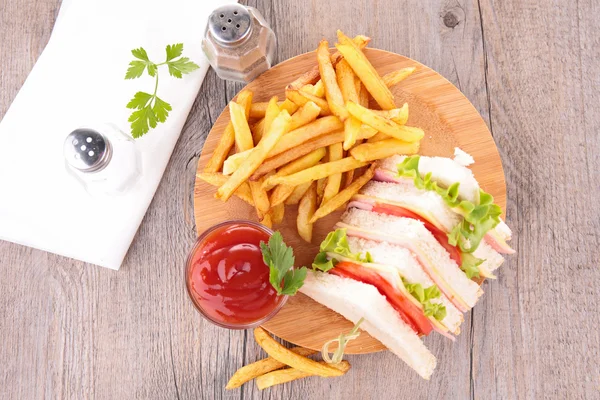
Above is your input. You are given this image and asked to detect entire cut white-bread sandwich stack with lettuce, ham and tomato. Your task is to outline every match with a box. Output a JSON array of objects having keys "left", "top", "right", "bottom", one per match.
[{"left": 300, "top": 152, "right": 514, "bottom": 379}]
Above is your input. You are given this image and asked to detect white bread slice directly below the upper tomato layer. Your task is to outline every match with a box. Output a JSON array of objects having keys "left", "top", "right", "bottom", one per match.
[{"left": 336, "top": 208, "right": 483, "bottom": 311}]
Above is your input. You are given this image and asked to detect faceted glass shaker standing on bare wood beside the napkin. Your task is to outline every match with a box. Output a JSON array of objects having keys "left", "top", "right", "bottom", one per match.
[{"left": 202, "top": 4, "right": 277, "bottom": 82}]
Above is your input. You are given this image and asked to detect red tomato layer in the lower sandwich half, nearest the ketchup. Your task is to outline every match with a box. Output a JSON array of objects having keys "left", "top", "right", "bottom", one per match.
[{"left": 329, "top": 261, "right": 433, "bottom": 335}]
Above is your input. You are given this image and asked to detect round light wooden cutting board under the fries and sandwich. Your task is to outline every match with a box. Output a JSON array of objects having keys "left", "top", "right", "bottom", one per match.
[{"left": 194, "top": 49, "right": 506, "bottom": 354}]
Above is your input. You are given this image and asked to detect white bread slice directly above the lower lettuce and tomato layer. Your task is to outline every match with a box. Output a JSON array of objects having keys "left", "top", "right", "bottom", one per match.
[{"left": 348, "top": 236, "right": 463, "bottom": 335}]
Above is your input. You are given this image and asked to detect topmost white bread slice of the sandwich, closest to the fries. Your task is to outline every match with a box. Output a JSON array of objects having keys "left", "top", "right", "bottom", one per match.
[{"left": 380, "top": 155, "right": 479, "bottom": 204}]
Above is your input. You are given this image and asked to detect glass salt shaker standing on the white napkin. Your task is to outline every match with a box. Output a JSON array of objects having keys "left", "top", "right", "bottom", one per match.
[{"left": 63, "top": 124, "right": 141, "bottom": 195}]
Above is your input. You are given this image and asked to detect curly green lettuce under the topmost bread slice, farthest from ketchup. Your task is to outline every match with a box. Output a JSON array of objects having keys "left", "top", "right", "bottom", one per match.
[{"left": 398, "top": 155, "right": 502, "bottom": 253}]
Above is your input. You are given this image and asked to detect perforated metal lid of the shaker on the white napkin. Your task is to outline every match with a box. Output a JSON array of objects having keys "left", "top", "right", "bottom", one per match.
[{"left": 63, "top": 128, "right": 112, "bottom": 172}]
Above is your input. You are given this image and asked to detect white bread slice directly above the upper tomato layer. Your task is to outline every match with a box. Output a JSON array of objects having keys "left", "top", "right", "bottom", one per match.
[{"left": 353, "top": 181, "right": 506, "bottom": 273}]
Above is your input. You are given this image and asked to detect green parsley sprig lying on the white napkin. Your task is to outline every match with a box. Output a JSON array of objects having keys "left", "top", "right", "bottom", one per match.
[{"left": 125, "top": 43, "right": 200, "bottom": 139}]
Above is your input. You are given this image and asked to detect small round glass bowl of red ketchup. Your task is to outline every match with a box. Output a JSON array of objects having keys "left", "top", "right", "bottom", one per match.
[{"left": 186, "top": 222, "right": 284, "bottom": 325}]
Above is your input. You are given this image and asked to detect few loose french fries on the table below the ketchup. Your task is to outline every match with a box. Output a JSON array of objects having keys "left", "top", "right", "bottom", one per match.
[{"left": 225, "top": 328, "right": 350, "bottom": 390}]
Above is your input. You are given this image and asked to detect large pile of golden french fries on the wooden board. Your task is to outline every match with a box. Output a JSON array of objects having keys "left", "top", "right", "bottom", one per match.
[{"left": 198, "top": 31, "right": 424, "bottom": 242}]
